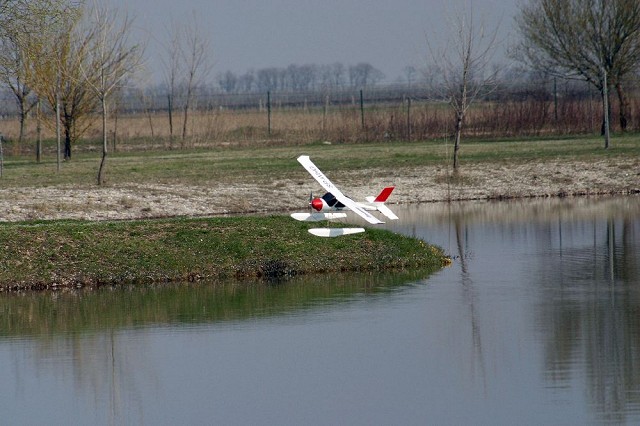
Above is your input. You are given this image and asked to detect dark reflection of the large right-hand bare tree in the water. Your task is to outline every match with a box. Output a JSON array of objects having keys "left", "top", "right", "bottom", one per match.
[{"left": 537, "top": 214, "right": 640, "bottom": 422}]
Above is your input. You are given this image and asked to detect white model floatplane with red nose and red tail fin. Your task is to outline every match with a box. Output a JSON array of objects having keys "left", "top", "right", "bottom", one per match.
[{"left": 291, "top": 155, "right": 398, "bottom": 237}]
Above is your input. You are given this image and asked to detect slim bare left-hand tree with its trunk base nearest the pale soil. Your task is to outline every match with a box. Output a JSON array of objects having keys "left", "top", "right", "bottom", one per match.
[{"left": 83, "top": 3, "right": 142, "bottom": 185}]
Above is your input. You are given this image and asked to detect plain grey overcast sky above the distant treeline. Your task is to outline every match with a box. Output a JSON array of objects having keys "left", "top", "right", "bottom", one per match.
[{"left": 106, "top": 0, "right": 519, "bottom": 82}]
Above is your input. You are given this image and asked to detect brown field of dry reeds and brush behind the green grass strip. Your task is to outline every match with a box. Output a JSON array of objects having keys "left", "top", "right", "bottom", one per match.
[{"left": 0, "top": 93, "right": 640, "bottom": 154}]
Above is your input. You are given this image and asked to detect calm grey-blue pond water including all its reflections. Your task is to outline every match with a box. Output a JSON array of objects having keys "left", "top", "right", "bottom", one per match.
[{"left": 0, "top": 197, "right": 640, "bottom": 425}]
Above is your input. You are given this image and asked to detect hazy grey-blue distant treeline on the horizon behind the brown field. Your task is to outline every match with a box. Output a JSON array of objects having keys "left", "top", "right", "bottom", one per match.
[{"left": 0, "top": 70, "right": 640, "bottom": 117}]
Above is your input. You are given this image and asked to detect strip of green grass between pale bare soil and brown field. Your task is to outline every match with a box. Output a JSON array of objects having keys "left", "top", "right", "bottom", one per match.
[{"left": 0, "top": 135, "right": 640, "bottom": 188}]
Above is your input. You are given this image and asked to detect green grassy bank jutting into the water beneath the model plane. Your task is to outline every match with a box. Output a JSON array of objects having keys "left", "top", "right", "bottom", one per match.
[{"left": 0, "top": 216, "right": 448, "bottom": 291}]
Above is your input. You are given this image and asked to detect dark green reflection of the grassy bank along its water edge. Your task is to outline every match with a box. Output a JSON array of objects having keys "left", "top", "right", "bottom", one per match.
[{"left": 0, "top": 270, "right": 428, "bottom": 339}]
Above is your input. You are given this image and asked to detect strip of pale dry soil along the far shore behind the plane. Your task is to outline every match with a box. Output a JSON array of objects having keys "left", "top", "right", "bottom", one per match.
[{"left": 0, "top": 158, "right": 640, "bottom": 222}]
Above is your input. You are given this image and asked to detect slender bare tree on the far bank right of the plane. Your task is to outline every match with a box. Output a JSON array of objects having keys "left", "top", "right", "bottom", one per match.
[{"left": 427, "top": 4, "right": 498, "bottom": 170}]
